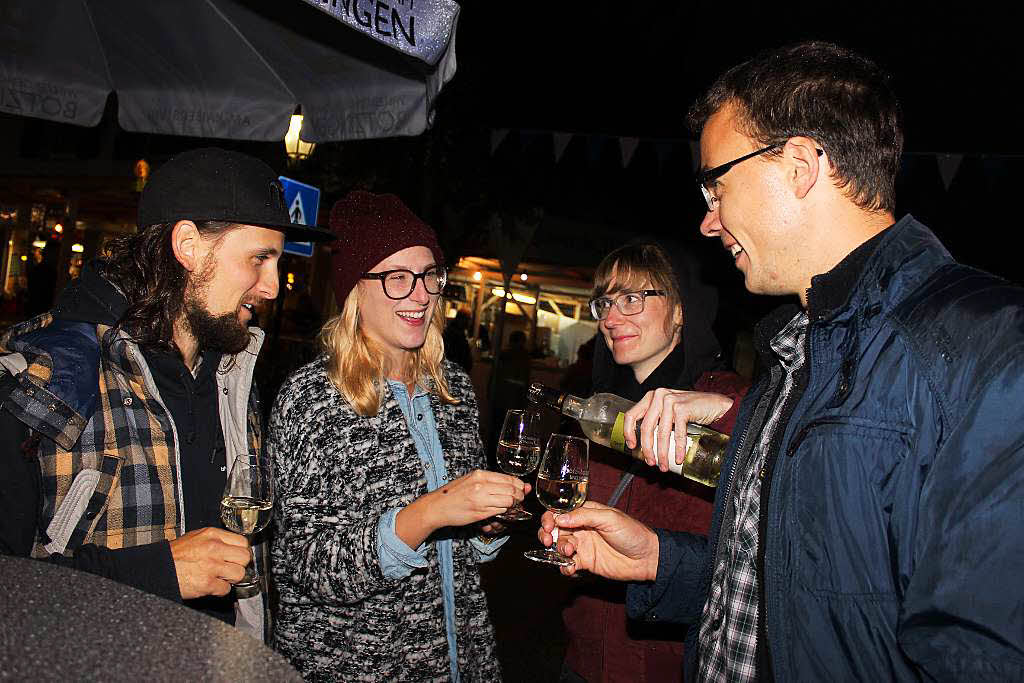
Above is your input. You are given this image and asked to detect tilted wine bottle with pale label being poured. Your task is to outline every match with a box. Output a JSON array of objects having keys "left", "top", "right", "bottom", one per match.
[{"left": 529, "top": 383, "right": 729, "bottom": 486}]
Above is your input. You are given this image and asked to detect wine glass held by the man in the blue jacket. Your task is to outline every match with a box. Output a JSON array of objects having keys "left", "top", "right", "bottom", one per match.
[{"left": 523, "top": 434, "right": 590, "bottom": 566}]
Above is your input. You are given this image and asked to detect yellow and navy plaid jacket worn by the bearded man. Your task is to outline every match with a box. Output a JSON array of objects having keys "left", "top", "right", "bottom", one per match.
[{"left": 0, "top": 313, "right": 262, "bottom": 557}]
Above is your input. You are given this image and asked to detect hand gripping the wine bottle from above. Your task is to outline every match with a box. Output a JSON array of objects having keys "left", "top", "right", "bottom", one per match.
[{"left": 623, "top": 389, "right": 732, "bottom": 472}]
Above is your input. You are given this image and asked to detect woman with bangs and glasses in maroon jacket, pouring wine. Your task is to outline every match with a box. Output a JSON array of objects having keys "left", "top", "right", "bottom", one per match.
[{"left": 562, "top": 240, "right": 745, "bottom": 683}]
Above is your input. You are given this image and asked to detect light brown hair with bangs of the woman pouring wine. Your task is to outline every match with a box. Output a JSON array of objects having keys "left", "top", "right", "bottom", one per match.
[{"left": 591, "top": 244, "right": 685, "bottom": 331}]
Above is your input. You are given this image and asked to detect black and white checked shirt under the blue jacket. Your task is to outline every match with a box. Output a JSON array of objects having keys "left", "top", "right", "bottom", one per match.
[{"left": 697, "top": 311, "right": 808, "bottom": 682}]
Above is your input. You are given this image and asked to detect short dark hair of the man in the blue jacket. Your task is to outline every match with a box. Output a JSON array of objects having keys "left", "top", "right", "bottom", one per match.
[{"left": 687, "top": 41, "right": 903, "bottom": 211}]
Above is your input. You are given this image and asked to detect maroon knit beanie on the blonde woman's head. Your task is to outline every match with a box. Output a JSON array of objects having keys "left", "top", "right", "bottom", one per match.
[{"left": 331, "top": 189, "right": 444, "bottom": 307}]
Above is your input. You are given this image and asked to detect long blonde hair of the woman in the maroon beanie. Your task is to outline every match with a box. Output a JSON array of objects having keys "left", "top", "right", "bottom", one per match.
[{"left": 319, "top": 286, "right": 459, "bottom": 417}]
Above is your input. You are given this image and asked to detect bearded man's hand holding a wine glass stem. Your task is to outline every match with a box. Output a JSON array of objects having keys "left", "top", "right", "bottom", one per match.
[{"left": 171, "top": 526, "right": 252, "bottom": 600}]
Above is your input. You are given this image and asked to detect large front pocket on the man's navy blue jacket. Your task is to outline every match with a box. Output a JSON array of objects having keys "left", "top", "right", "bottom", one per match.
[{"left": 787, "top": 418, "right": 913, "bottom": 598}]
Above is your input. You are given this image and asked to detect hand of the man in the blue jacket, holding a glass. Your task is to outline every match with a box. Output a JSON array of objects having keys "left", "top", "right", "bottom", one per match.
[{"left": 537, "top": 501, "right": 658, "bottom": 581}]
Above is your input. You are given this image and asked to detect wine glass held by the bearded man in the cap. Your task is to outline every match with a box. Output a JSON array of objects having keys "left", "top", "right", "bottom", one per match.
[{"left": 220, "top": 453, "right": 273, "bottom": 592}]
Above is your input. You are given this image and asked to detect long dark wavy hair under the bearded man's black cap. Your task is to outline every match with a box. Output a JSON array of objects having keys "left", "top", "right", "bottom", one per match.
[{"left": 99, "top": 220, "right": 238, "bottom": 352}]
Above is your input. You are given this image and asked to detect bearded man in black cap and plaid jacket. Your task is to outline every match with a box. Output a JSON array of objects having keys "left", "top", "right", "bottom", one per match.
[{"left": 0, "top": 148, "right": 333, "bottom": 639}]
